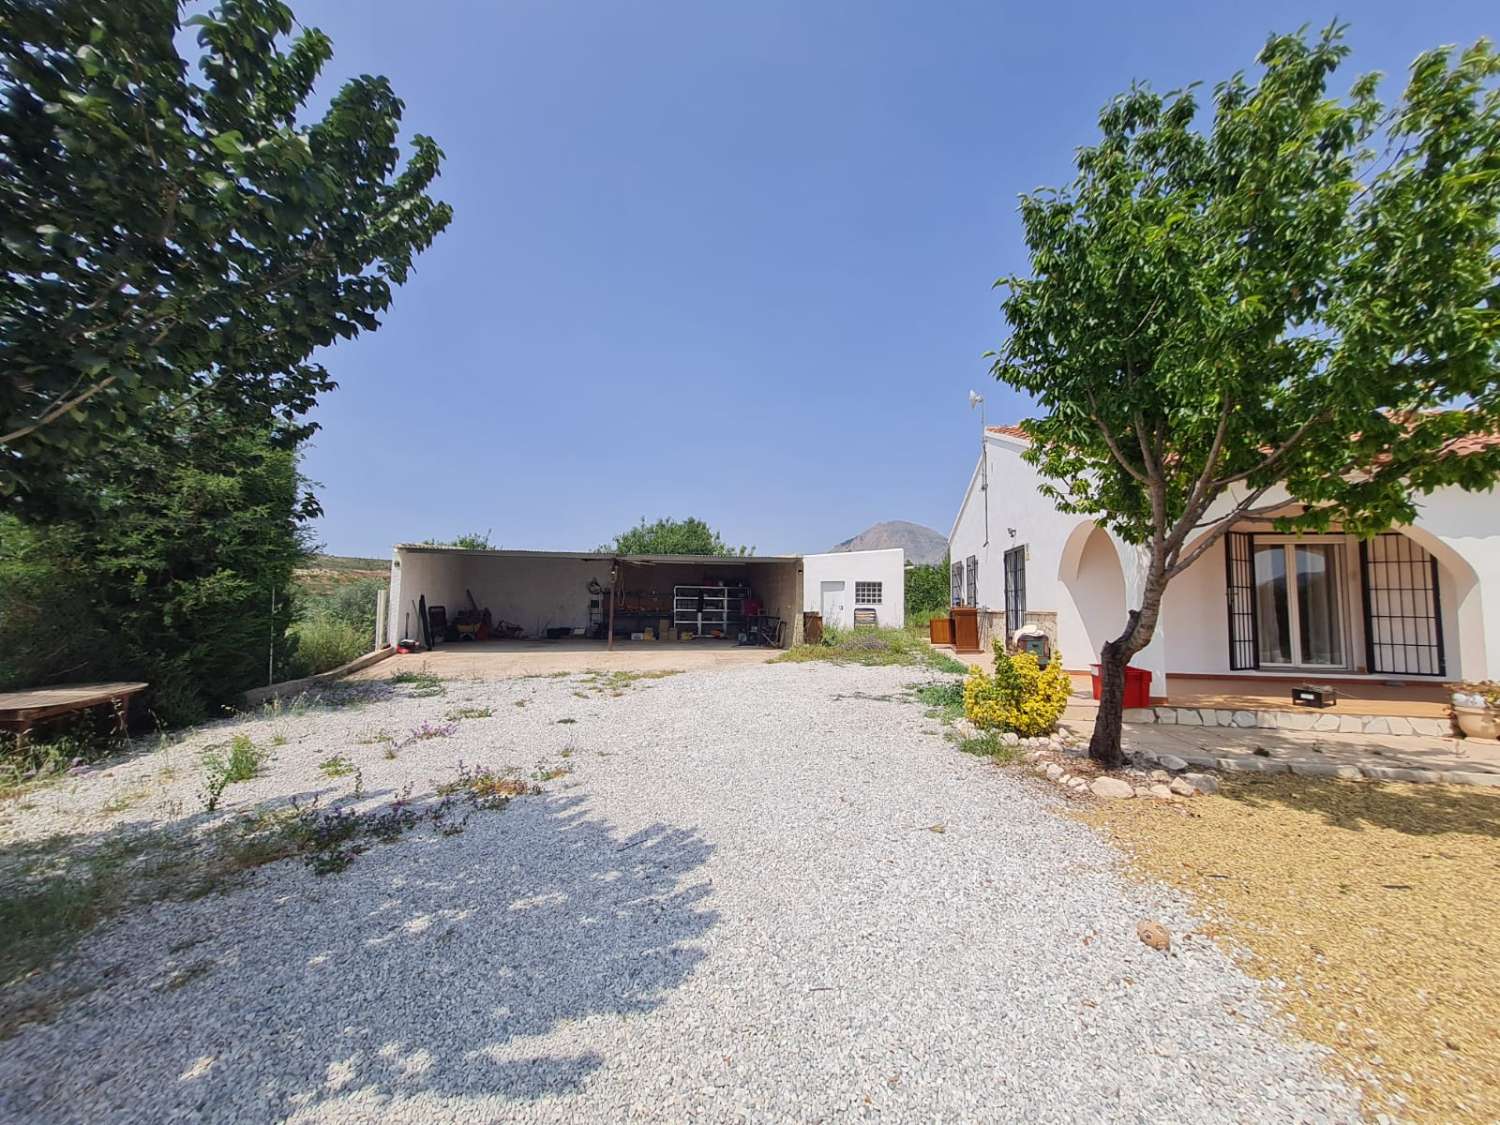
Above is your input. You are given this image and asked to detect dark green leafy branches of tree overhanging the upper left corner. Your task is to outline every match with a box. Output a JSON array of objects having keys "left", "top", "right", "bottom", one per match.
[{"left": 0, "top": 0, "right": 452, "bottom": 518}]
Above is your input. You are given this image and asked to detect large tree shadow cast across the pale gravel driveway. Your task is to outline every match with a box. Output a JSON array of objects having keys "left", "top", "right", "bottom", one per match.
[{"left": 0, "top": 797, "right": 719, "bottom": 1121}]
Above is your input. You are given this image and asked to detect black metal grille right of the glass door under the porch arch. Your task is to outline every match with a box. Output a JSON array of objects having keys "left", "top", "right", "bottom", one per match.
[{"left": 1359, "top": 533, "right": 1448, "bottom": 677}]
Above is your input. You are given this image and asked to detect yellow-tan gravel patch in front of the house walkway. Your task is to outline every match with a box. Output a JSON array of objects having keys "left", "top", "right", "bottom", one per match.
[{"left": 1080, "top": 777, "right": 1500, "bottom": 1122}]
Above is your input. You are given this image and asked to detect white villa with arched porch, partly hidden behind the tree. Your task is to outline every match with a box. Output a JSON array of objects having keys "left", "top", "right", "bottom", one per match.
[{"left": 948, "top": 426, "right": 1500, "bottom": 723}]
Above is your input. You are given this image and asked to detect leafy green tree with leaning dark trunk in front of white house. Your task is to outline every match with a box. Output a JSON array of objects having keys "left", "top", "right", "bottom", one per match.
[{"left": 993, "top": 27, "right": 1500, "bottom": 765}]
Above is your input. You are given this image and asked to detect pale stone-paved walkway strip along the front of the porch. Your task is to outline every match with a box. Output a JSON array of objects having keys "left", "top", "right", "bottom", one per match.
[{"left": 1062, "top": 714, "right": 1500, "bottom": 785}]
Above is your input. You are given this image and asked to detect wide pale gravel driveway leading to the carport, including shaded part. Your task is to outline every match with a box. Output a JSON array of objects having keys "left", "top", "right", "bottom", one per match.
[{"left": 0, "top": 665, "right": 1358, "bottom": 1122}]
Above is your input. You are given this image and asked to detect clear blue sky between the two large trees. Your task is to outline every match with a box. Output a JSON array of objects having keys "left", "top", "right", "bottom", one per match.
[{"left": 283, "top": 0, "right": 1500, "bottom": 555}]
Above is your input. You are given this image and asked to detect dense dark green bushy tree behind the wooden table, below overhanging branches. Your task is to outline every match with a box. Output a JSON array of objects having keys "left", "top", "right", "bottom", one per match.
[{"left": 0, "top": 419, "right": 317, "bottom": 725}]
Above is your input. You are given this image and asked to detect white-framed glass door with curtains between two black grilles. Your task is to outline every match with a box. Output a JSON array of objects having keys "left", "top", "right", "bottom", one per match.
[{"left": 1256, "top": 537, "right": 1346, "bottom": 668}]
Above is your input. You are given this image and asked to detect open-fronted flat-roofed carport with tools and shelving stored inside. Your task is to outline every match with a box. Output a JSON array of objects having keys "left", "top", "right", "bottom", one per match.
[{"left": 387, "top": 543, "right": 803, "bottom": 656}]
